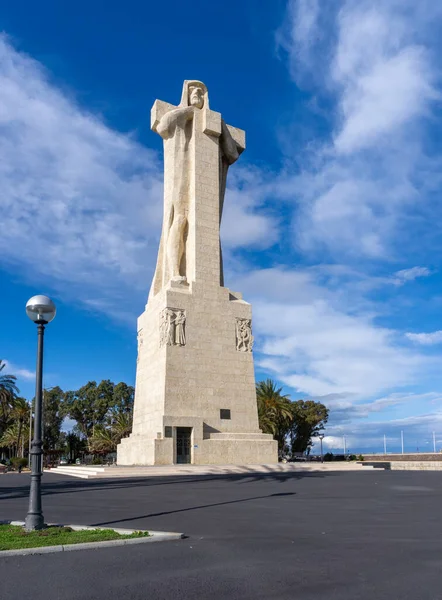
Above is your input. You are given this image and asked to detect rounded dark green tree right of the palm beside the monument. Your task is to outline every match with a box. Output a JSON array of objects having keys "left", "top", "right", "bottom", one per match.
[{"left": 289, "top": 400, "right": 329, "bottom": 454}]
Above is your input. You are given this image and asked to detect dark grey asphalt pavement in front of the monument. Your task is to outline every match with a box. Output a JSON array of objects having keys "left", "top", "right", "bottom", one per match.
[{"left": 0, "top": 471, "right": 442, "bottom": 600}]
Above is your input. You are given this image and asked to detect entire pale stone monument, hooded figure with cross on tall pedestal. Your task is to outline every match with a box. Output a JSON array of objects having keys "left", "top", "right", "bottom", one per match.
[{"left": 117, "top": 81, "right": 277, "bottom": 465}]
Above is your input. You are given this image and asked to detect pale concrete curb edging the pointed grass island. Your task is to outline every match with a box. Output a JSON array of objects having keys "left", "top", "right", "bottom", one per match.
[{"left": 0, "top": 521, "right": 185, "bottom": 559}]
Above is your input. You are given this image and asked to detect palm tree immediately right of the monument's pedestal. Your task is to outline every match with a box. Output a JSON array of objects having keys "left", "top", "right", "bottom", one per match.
[{"left": 256, "top": 379, "right": 293, "bottom": 452}]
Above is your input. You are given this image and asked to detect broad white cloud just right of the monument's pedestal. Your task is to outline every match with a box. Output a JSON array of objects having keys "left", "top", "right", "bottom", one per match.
[{"left": 235, "top": 268, "right": 432, "bottom": 403}]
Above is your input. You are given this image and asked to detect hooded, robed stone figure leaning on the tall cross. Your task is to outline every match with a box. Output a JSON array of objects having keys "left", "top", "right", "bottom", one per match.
[{"left": 150, "top": 81, "right": 244, "bottom": 297}]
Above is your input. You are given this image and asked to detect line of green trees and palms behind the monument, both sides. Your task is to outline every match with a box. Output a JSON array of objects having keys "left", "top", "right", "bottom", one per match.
[{"left": 0, "top": 360, "right": 328, "bottom": 460}]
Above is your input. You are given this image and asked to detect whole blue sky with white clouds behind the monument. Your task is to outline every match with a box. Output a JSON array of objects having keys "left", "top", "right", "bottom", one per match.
[{"left": 0, "top": 0, "right": 442, "bottom": 450}]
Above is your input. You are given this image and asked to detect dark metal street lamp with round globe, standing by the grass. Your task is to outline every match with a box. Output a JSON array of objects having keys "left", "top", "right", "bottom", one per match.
[{"left": 25, "top": 296, "right": 57, "bottom": 531}]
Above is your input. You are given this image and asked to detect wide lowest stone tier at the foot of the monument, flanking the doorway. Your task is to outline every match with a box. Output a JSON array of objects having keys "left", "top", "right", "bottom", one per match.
[{"left": 117, "top": 427, "right": 278, "bottom": 466}]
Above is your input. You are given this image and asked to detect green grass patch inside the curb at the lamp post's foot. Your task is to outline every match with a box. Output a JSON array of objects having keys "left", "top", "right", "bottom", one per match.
[{"left": 0, "top": 525, "right": 149, "bottom": 550}]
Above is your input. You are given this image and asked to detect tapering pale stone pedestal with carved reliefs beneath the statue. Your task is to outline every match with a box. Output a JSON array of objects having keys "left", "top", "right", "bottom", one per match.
[{"left": 117, "top": 281, "right": 277, "bottom": 465}]
